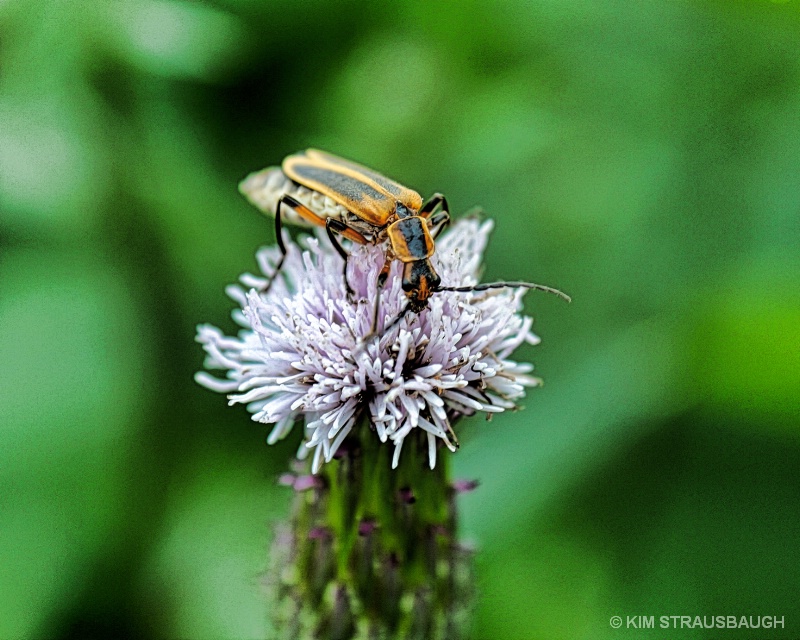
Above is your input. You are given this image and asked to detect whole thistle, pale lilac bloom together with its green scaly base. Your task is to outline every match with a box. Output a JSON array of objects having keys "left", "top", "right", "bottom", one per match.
[{"left": 196, "top": 218, "right": 564, "bottom": 640}]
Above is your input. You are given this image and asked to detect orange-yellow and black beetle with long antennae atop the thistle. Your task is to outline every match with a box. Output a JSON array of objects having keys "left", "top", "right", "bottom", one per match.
[{"left": 239, "top": 149, "right": 569, "bottom": 324}]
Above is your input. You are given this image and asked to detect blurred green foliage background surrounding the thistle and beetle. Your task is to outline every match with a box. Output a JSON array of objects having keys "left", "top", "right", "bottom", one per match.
[{"left": 0, "top": 0, "right": 800, "bottom": 640}]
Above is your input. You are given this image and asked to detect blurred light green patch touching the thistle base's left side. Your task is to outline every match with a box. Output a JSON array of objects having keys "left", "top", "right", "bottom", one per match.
[{"left": 141, "top": 452, "right": 288, "bottom": 638}]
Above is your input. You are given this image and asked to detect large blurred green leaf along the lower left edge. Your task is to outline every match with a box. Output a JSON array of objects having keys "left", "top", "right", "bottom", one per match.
[{"left": 0, "top": 251, "right": 148, "bottom": 637}]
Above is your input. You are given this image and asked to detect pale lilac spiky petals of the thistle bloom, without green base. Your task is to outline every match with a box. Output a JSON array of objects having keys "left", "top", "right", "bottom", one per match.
[{"left": 195, "top": 218, "right": 539, "bottom": 473}]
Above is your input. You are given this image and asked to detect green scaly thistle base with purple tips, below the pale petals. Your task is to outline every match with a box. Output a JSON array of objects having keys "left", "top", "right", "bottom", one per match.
[{"left": 270, "top": 421, "right": 472, "bottom": 640}]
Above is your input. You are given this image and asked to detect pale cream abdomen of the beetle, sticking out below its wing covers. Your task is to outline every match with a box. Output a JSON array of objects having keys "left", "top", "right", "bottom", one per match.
[{"left": 239, "top": 167, "right": 350, "bottom": 227}]
